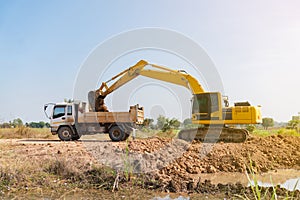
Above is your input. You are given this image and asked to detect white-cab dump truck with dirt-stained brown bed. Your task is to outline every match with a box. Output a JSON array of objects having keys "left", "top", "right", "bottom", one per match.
[{"left": 44, "top": 102, "right": 144, "bottom": 141}]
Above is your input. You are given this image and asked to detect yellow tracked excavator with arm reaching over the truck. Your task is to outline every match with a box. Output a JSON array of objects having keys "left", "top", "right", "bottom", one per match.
[{"left": 88, "top": 60, "right": 262, "bottom": 142}]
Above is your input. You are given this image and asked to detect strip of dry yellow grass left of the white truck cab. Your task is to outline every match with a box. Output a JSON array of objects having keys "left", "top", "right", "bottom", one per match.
[{"left": 0, "top": 126, "right": 52, "bottom": 139}]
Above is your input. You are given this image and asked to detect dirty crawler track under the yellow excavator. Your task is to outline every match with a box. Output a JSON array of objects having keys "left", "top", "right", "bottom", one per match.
[{"left": 178, "top": 127, "right": 249, "bottom": 143}]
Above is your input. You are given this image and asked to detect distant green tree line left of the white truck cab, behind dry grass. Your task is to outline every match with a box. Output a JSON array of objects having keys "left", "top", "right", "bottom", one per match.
[{"left": 0, "top": 118, "right": 50, "bottom": 128}]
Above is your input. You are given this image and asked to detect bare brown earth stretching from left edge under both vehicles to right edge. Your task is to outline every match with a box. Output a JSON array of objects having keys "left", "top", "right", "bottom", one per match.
[{"left": 0, "top": 135, "right": 300, "bottom": 198}]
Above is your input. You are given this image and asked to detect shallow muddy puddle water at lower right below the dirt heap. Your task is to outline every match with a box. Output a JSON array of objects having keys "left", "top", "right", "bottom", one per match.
[{"left": 193, "top": 169, "right": 300, "bottom": 191}]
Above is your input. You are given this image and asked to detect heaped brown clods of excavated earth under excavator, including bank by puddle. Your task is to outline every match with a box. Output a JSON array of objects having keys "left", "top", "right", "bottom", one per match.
[{"left": 87, "top": 135, "right": 300, "bottom": 195}]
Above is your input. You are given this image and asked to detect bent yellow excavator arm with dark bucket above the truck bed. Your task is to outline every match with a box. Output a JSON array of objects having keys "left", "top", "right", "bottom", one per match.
[{"left": 89, "top": 60, "right": 204, "bottom": 111}]
